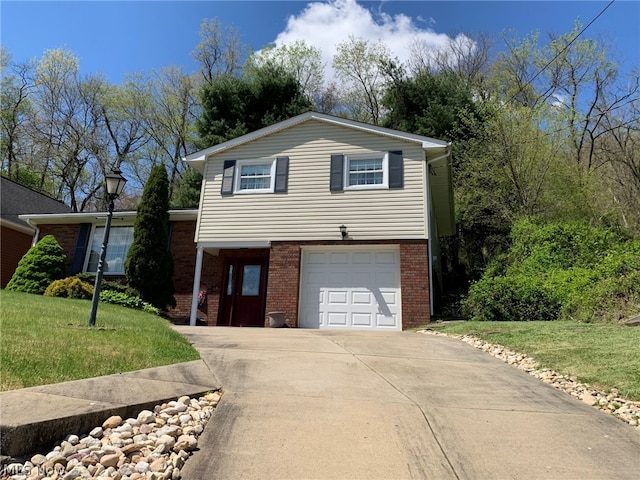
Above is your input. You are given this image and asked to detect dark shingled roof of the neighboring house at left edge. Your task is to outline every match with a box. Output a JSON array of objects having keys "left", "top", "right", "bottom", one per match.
[{"left": 0, "top": 177, "right": 71, "bottom": 231}]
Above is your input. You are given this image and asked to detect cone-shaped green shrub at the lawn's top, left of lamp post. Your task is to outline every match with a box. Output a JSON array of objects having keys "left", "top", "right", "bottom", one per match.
[{"left": 6, "top": 235, "right": 67, "bottom": 295}]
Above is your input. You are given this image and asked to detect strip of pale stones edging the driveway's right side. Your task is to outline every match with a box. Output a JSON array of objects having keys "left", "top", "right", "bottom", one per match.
[{"left": 418, "top": 329, "right": 640, "bottom": 431}]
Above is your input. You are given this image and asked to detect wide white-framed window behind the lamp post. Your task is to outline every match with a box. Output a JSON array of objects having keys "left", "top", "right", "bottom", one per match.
[{"left": 84, "top": 226, "right": 133, "bottom": 275}]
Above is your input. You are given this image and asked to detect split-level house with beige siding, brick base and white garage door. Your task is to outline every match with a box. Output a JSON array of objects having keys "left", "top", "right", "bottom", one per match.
[{"left": 21, "top": 112, "right": 455, "bottom": 331}]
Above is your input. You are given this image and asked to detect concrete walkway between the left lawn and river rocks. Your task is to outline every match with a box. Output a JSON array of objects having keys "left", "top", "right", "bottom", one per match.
[{"left": 0, "top": 360, "right": 220, "bottom": 457}]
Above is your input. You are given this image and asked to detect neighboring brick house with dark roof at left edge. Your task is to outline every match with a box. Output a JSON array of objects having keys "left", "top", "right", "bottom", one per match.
[{"left": 0, "top": 177, "right": 71, "bottom": 288}]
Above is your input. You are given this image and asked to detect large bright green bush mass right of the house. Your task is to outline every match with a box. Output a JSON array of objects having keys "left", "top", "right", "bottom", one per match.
[{"left": 463, "top": 220, "right": 640, "bottom": 322}]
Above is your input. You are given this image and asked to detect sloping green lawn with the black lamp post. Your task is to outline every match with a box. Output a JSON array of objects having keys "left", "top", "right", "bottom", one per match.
[{"left": 0, "top": 290, "right": 200, "bottom": 390}]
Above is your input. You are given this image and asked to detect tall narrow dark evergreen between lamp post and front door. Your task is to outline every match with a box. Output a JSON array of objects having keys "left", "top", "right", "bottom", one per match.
[{"left": 125, "top": 165, "right": 176, "bottom": 310}]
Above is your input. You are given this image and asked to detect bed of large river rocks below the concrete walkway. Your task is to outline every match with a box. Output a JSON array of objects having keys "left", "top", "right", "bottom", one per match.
[{"left": 0, "top": 392, "right": 220, "bottom": 480}]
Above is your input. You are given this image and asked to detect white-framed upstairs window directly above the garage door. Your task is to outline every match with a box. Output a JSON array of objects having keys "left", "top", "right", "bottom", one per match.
[{"left": 344, "top": 152, "right": 389, "bottom": 190}]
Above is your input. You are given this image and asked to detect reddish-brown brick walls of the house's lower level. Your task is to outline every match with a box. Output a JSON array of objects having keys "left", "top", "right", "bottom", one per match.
[{"left": 28, "top": 220, "right": 430, "bottom": 330}]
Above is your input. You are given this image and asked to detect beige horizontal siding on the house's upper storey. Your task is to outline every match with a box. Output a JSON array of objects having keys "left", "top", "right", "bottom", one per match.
[{"left": 196, "top": 120, "right": 426, "bottom": 242}]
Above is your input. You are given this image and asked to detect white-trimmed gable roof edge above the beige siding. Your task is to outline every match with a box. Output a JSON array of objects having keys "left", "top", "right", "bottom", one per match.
[{"left": 183, "top": 112, "right": 450, "bottom": 171}]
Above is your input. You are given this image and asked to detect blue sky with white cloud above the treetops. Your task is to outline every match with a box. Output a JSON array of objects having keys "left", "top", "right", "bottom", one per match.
[{"left": 0, "top": 0, "right": 640, "bottom": 83}]
